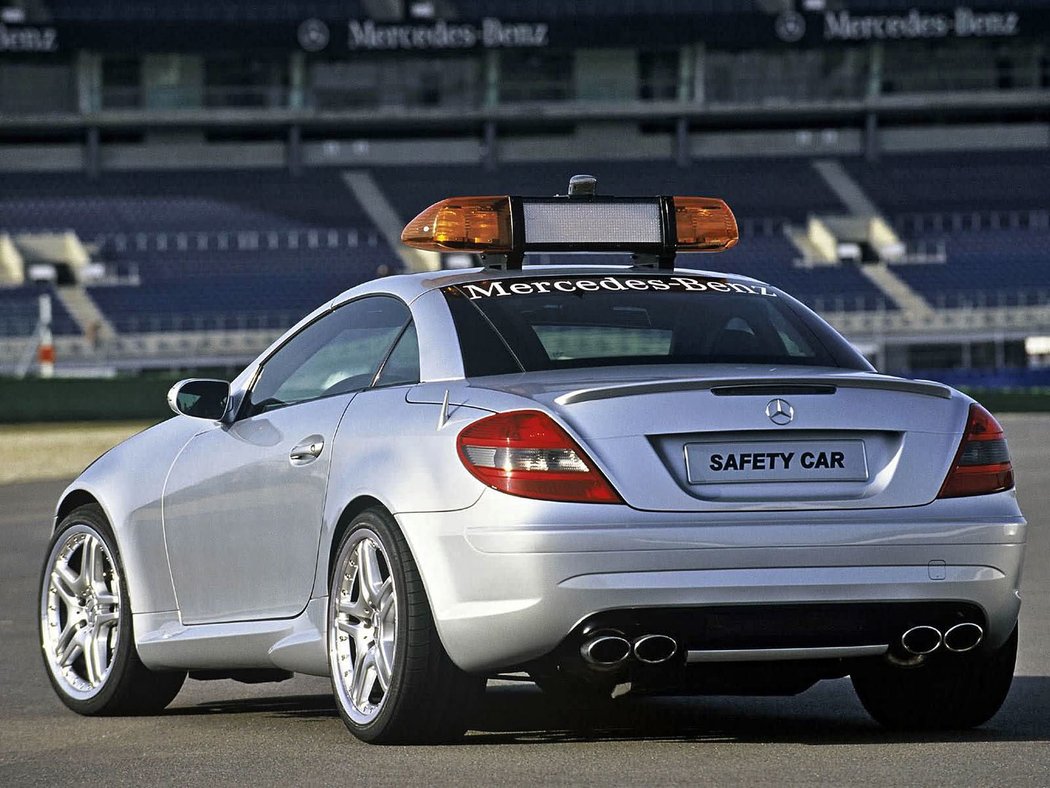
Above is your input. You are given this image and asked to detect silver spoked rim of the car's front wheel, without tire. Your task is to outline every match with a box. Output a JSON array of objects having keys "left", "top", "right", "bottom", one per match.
[{"left": 40, "top": 525, "right": 121, "bottom": 700}]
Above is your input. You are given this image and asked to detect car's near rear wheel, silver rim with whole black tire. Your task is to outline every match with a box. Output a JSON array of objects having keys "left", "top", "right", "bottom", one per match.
[{"left": 328, "top": 509, "right": 485, "bottom": 744}]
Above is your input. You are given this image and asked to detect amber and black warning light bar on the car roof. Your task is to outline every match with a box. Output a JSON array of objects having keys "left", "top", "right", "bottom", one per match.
[{"left": 401, "top": 175, "right": 739, "bottom": 268}]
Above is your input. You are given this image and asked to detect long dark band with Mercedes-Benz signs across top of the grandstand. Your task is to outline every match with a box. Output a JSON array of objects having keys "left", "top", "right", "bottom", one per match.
[{"left": 0, "top": 6, "right": 1033, "bottom": 59}]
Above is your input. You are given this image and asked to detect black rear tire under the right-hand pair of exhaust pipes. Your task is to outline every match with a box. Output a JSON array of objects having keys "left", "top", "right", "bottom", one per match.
[{"left": 852, "top": 627, "right": 1017, "bottom": 730}]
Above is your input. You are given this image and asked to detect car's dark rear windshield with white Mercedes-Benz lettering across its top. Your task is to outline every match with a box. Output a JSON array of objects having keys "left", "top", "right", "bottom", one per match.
[{"left": 443, "top": 274, "right": 869, "bottom": 377}]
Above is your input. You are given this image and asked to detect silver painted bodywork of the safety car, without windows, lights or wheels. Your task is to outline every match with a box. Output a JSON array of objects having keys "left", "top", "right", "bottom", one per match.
[{"left": 53, "top": 267, "right": 1027, "bottom": 675}]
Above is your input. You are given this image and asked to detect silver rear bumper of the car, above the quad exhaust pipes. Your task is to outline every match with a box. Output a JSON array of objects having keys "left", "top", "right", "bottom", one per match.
[{"left": 398, "top": 492, "right": 1026, "bottom": 671}]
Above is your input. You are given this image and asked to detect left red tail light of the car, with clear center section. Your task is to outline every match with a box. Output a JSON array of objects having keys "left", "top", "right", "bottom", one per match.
[{"left": 457, "top": 411, "right": 623, "bottom": 503}]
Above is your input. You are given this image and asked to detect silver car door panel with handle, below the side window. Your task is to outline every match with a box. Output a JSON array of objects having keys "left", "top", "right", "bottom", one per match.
[{"left": 163, "top": 395, "right": 353, "bottom": 623}]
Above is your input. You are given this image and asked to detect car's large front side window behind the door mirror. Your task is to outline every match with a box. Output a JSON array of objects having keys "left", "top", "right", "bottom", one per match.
[{"left": 244, "top": 295, "right": 412, "bottom": 416}]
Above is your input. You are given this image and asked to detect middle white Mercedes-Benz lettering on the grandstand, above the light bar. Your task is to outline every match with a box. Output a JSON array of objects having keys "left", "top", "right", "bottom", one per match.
[{"left": 350, "top": 17, "right": 549, "bottom": 49}]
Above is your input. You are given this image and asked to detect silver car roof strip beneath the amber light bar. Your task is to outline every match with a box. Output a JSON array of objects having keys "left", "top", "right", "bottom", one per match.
[{"left": 329, "top": 265, "right": 767, "bottom": 307}]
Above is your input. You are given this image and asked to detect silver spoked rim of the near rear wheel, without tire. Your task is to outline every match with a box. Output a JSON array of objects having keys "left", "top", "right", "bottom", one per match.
[{"left": 329, "top": 528, "right": 397, "bottom": 725}]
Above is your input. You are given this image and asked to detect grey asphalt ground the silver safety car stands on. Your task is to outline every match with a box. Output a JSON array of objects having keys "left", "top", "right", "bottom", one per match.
[{"left": 0, "top": 416, "right": 1050, "bottom": 786}]
